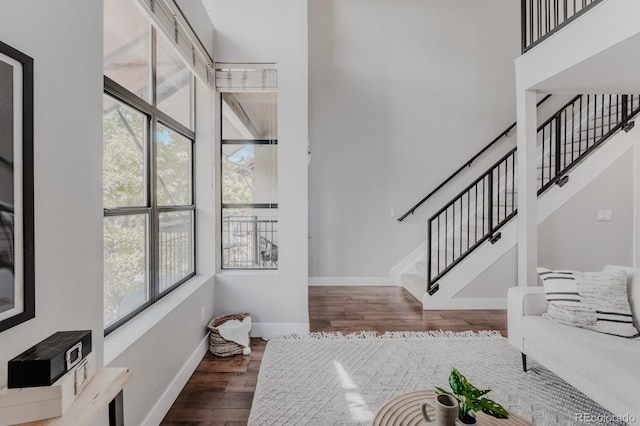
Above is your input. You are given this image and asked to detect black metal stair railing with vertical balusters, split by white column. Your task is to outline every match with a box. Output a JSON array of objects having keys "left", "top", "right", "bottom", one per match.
[{"left": 427, "top": 95, "right": 640, "bottom": 294}]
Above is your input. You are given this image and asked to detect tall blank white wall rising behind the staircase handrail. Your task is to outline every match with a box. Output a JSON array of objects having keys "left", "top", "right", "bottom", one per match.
[{"left": 309, "top": 0, "right": 520, "bottom": 277}]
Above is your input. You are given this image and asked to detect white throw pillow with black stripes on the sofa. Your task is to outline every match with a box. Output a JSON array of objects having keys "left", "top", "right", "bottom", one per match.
[{"left": 538, "top": 268, "right": 640, "bottom": 338}]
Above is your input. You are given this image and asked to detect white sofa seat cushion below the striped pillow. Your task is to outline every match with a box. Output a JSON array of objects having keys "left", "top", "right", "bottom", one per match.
[{"left": 522, "top": 316, "right": 640, "bottom": 407}]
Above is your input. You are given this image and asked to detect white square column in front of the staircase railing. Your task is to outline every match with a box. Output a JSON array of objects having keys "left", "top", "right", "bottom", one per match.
[{"left": 516, "top": 90, "right": 538, "bottom": 287}]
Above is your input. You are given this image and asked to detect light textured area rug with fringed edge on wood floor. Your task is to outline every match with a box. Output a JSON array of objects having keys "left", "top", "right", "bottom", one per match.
[{"left": 249, "top": 331, "right": 624, "bottom": 426}]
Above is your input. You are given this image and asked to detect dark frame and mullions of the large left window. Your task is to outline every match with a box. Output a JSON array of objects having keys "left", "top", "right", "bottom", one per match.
[{"left": 103, "top": 26, "right": 197, "bottom": 336}]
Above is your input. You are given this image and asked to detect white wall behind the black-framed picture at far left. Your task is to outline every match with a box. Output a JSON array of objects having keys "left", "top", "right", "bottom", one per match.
[{"left": 0, "top": 0, "right": 103, "bottom": 387}]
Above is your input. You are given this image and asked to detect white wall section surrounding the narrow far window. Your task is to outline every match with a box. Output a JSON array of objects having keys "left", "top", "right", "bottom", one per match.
[{"left": 205, "top": 0, "right": 309, "bottom": 334}]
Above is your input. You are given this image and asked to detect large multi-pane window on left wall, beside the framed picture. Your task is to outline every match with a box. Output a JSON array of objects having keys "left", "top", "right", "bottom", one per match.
[{"left": 103, "top": 0, "right": 195, "bottom": 333}]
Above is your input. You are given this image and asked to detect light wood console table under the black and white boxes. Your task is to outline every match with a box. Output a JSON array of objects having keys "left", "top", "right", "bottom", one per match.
[{"left": 22, "top": 368, "right": 132, "bottom": 426}]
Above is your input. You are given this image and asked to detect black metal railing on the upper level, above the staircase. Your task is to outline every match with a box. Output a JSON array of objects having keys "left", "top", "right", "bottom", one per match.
[{"left": 520, "top": 0, "right": 603, "bottom": 53}]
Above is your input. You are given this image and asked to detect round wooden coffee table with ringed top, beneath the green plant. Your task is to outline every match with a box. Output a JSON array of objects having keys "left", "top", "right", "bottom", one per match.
[{"left": 373, "top": 390, "right": 533, "bottom": 426}]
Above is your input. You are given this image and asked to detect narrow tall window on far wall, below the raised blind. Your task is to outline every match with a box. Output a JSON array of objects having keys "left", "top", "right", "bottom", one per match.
[{"left": 220, "top": 91, "right": 278, "bottom": 269}]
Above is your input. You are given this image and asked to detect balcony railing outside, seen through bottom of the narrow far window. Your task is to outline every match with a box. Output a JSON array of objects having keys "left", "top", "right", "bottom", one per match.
[{"left": 222, "top": 216, "right": 278, "bottom": 269}]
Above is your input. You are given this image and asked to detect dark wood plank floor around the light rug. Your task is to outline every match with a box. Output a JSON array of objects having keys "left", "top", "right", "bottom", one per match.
[{"left": 162, "top": 287, "right": 507, "bottom": 426}]
